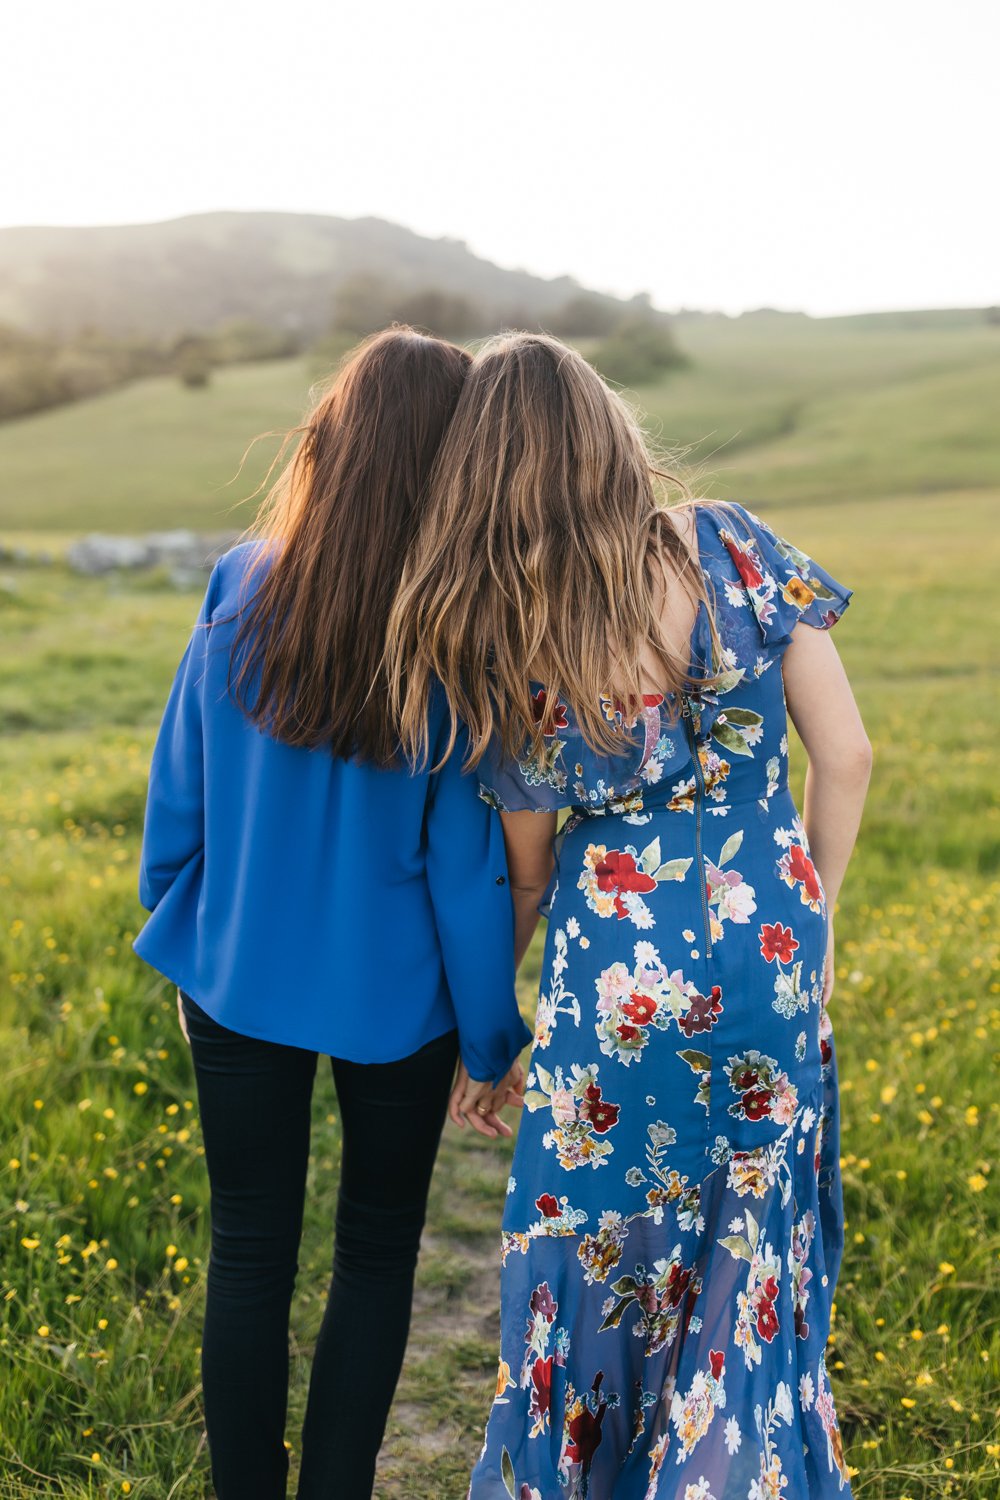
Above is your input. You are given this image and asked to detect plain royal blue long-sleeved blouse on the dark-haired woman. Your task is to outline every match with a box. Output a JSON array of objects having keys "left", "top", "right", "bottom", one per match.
[{"left": 135, "top": 543, "right": 531, "bottom": 1080}]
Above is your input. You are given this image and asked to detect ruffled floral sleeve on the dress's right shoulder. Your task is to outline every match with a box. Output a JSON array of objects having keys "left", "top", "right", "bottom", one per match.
[{"left": 720, "top": 504, "right": 853, "bottom": 645}]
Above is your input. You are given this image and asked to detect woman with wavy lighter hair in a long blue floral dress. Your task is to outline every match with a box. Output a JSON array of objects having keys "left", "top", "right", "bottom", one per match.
[{"left": 386, "top": 335, "right": 870, "bottom": 1500}]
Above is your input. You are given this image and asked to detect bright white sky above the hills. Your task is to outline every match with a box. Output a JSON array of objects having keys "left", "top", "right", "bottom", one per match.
[{"left": 0, "top": 0, "right": 1000, "bottom": 314}]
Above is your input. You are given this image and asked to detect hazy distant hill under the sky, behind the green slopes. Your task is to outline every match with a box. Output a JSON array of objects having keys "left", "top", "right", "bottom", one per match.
[{"left": 0, "top": 213, "right": 629, "bottom": 338}]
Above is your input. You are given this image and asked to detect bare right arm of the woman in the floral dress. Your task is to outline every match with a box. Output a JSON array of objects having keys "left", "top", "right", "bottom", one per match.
[{"left": 781, "top": 624, "right": 871, "bottom": 912}]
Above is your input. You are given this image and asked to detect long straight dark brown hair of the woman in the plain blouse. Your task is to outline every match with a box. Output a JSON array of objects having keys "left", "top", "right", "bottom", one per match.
[{"left": 229, "top": 327, "right": 471, "bottom": 765}]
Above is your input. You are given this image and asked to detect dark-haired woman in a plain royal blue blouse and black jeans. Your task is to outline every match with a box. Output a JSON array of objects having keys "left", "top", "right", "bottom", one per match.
[{"left": 135, "top": 329, "right": 539, "bottom": 1500}]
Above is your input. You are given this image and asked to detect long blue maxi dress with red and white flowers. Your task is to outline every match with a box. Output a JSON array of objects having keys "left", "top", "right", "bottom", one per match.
[{"left": 469, "top": 506, "right": 850, "bottom": 1500}]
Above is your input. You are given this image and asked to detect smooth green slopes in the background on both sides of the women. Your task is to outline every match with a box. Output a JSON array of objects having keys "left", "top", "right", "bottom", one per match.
[{"left": 0, "top": 315, "right": 1000, "bottom": 534}]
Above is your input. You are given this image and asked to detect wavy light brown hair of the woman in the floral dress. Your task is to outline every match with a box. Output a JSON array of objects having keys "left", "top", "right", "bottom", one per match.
[{"left": 388, "top": 333, "right": 718, "bottom": 765}]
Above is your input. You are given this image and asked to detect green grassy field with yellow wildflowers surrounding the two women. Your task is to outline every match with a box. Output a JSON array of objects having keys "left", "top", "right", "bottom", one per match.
[{"left": 0, "top": 320, "right": 1000, "bottom": 1500}]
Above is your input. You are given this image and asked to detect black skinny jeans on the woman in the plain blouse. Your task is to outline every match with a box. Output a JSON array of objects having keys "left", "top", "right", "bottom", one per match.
[{"left": 183, "top": 996, "right": 457, "bottom": 1500}]
